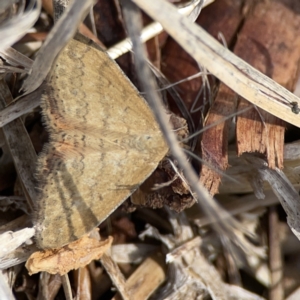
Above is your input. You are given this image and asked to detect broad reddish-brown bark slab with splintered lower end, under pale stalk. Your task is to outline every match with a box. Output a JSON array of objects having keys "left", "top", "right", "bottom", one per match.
[{"left": 234, "top": 0, "right": 300, "bottom": 168}]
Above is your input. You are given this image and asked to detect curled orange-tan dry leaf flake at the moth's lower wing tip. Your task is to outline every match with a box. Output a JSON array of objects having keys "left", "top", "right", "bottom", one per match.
[{"left": 25, "top": 236, "right": 113, "bottom": 275}]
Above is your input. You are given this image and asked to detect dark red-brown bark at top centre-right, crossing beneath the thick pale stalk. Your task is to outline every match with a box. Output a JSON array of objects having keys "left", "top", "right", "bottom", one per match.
[{"left": 161, "top": 0, "right": 243, "bottom": 118}]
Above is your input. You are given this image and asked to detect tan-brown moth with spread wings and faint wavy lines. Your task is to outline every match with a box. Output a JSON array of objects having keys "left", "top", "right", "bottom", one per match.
[{"left": 35, "top": 40, "right": 168, "bottom": 249}]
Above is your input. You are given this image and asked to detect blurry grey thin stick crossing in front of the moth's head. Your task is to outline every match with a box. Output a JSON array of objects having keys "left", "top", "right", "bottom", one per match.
[{"left": 123, "top": 0, "right": 245, "bottom": 241}]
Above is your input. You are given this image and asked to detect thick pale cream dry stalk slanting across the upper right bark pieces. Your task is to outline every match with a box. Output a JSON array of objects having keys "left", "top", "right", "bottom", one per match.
[{"left": 134, "top": 0, "right": 300, "bottom": 127}]
